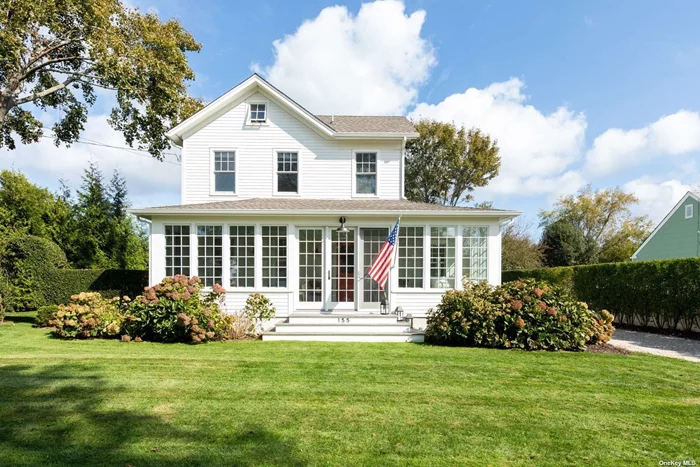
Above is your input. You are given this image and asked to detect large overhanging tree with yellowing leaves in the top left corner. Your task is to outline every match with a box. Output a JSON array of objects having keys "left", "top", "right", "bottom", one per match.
[{"left": 0, "top": 0, "right": 201, "bottom": 158}]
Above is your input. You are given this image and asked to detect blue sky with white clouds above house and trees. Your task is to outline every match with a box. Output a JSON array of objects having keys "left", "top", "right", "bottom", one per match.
[{"left": 2, "top": 0, "right": 700, "bottom": 227}]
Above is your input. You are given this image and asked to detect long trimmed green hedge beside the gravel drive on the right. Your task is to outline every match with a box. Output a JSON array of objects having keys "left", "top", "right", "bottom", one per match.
[{"left": 502, "top": 258, "right": 700, "bottom": 331}]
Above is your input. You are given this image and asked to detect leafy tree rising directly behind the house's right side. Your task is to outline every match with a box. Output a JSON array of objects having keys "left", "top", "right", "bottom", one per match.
[{"left": 405, "top": 120, "right": 501, "bottom": 206}]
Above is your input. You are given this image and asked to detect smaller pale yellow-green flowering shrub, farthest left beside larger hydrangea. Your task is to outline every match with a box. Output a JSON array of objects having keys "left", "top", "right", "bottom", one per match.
[{"left": 48, "top": 292, "right": 126, "bottom": 338}]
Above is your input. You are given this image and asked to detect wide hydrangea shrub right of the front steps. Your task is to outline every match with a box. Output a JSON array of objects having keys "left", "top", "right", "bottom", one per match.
[{"left": 426, "top": 280, "right": 613, "bottom": 350}]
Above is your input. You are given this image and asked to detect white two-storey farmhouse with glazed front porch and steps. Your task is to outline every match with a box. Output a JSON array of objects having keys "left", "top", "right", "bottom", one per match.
[{"left": 131, "top": 75, "right": 519, "bottom": 341}]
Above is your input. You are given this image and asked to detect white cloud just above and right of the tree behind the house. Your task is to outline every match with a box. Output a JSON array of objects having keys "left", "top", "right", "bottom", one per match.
[{"left": 409, "top": 78, "right": 586, "bottom": 195}]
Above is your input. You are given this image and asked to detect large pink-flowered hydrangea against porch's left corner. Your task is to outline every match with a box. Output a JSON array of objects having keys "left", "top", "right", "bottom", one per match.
[{"left": 124, "top": 275, "right": 233, "bottom": 344}]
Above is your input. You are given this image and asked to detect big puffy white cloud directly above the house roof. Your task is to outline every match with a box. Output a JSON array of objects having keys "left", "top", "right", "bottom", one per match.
[{"left": 252, "top": 0, "right": 436, "bottom": 115}]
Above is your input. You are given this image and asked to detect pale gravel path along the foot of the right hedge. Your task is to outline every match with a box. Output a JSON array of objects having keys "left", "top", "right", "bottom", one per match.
[{"left": 610, "top": 329, "right": 700, "bottom": 363}]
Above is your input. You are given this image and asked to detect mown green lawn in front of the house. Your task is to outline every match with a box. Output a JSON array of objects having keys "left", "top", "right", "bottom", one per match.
[{"left": 0, "top": 316, "right": 700, "bottom": 467}]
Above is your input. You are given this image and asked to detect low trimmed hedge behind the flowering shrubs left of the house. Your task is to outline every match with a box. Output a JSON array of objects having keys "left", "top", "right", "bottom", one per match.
[{"left": 37, "top": 269, "right": 148, "bottom": 305}]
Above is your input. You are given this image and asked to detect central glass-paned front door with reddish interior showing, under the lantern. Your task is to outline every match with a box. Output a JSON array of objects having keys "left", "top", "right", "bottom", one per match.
[{"left": 330, "top": 230, "right": 355, "bottom": 309}]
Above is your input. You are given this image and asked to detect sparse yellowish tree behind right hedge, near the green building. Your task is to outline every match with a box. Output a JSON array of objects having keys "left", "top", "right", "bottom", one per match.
[{"left": 540, "top": 185, "right": 652, "bottom": 265}]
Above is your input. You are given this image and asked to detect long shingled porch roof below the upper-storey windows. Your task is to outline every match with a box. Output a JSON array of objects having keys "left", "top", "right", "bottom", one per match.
[{"left": 131, "top": 198, "right": 513, "bottom": 215}]
